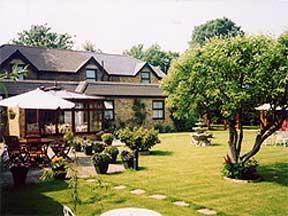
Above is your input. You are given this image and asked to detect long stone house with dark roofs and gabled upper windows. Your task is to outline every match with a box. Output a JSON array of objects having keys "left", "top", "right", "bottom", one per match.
[{"left": 0, "top": 44, "right": 173, "bottom": 136}]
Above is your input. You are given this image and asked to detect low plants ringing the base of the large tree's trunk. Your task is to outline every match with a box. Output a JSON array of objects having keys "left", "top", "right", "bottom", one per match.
[{"left": 222, "top": 155, "right": 259, "bottom": 180}]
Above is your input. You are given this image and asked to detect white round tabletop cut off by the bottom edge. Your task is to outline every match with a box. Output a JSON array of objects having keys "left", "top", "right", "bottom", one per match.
[{"left": 101, "top": 208, "right": 161, "bottom": 216}]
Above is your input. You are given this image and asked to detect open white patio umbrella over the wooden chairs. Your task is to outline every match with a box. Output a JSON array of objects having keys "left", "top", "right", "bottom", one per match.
[{"left": 0, "top": 88, "right": 75, "bottom": 110}]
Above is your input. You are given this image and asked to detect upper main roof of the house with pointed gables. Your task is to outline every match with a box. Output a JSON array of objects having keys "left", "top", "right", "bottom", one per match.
[{"left": 0, "top": 44, "right": 165, "bottom": 78}]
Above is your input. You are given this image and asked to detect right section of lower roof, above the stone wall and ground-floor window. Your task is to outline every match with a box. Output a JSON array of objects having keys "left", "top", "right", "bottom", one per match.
[{"left": 84, "top": 82, "right": 165, "bottom": 97}]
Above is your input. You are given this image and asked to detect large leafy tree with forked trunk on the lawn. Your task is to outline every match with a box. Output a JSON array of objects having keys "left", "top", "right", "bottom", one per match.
[{"left": 162, "top": 34, "right": 288, "bottom": 163}]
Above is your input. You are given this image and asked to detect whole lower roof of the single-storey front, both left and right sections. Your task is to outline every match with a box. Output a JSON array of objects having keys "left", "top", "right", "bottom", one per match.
[{"left": 0, "top": 80, "right": 165, "bottom": 97}]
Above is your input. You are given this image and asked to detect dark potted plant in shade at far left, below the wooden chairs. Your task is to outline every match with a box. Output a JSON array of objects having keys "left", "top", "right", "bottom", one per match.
[{"left": 9, "top": 152, "right": 31, "bottom": 186}]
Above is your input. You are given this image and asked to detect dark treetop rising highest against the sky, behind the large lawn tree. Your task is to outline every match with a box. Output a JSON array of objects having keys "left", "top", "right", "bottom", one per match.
[{"left": 189, "top": 17, "right": 244, "bottom": 47}]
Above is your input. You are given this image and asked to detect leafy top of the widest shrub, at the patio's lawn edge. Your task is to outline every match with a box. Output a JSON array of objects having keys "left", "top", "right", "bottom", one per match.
[{"left": 117, "top": 127, "right": 160, "bottom": 151}]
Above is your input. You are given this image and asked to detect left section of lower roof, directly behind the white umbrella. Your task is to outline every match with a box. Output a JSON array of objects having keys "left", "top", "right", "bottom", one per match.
[{"left": 0, "top": 80, "right": 78, "bottom": 95}]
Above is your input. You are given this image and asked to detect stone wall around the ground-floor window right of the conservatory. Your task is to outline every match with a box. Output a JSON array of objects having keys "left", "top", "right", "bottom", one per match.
[{"left": 113, "top": 98, "right": 174, "bottom": 128}]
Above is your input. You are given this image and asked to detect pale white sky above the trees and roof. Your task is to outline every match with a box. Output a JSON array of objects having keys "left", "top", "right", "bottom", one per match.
[{"left": 0, "top": 0, "right": 288, "bottom": 53}]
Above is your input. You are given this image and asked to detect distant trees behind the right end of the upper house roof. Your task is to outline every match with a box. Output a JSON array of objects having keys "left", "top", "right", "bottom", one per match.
[{"left": 123, "top": 44, "right": 179, "bottom": 73}]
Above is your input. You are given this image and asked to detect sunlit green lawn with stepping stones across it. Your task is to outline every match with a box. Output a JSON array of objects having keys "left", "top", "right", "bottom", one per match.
[{"left": 2, "top": 130, "right": 288, "bottom": 216}]
